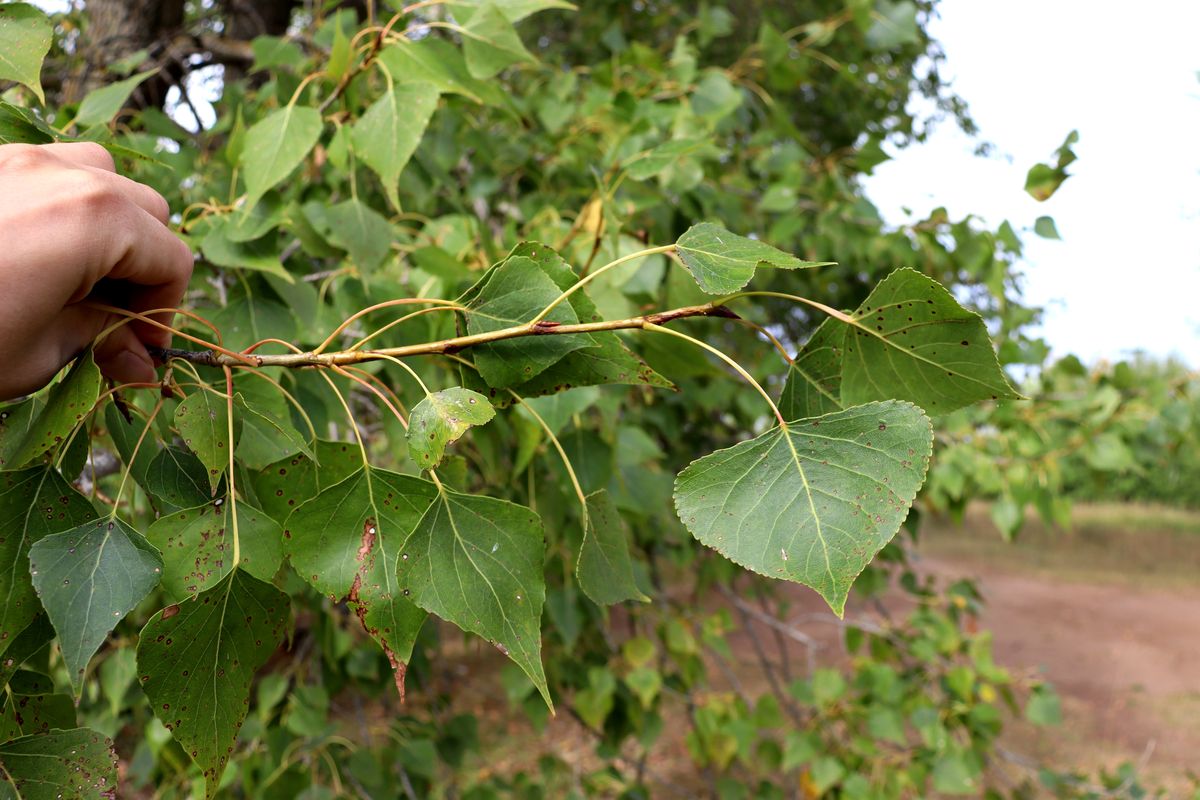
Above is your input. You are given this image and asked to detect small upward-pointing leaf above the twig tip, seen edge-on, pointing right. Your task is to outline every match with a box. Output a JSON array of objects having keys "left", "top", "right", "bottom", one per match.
[{"left": 676, "top": 222, "right": 826, "bottom": 294}]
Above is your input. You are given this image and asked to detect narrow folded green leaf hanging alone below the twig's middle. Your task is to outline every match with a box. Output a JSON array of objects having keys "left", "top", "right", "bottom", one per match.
[{"left": 575, "top": 489, "right": 650, "bottom": 606}]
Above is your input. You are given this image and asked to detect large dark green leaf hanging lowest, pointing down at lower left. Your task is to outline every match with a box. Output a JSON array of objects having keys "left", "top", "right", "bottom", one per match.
[{"left": 138, "top": 570, "right": 288, "bottom": 798}]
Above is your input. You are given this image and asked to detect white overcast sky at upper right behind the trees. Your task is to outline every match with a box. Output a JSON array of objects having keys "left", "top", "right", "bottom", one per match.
[{"left": 868, "top": 0, "right": 1200, "bottom": 367}]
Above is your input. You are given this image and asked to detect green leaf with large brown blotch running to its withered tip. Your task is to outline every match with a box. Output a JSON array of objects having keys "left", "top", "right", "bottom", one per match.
[{"left": 283, "top": 468, "right": 437, "bottom": 697}]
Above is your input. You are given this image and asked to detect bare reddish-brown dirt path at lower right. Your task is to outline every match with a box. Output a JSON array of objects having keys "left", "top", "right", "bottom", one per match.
[{"left": 920, "top": 551, "right": 1200, "bottom": 786}]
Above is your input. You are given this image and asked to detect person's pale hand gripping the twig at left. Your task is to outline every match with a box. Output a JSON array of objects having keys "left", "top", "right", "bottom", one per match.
[{"left": 0, "top": 143, "right": 193, "bottom": 399}]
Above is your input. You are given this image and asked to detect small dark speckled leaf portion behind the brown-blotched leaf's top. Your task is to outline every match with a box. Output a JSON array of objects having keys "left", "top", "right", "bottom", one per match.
[{"left": 252, "top": 440, "right": 362, "bottom": 525}]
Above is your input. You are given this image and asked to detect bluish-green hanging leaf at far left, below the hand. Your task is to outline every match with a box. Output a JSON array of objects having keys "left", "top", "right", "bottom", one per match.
[{"left": 29, "top": 517, "right": 162, "bottom": 694}]
